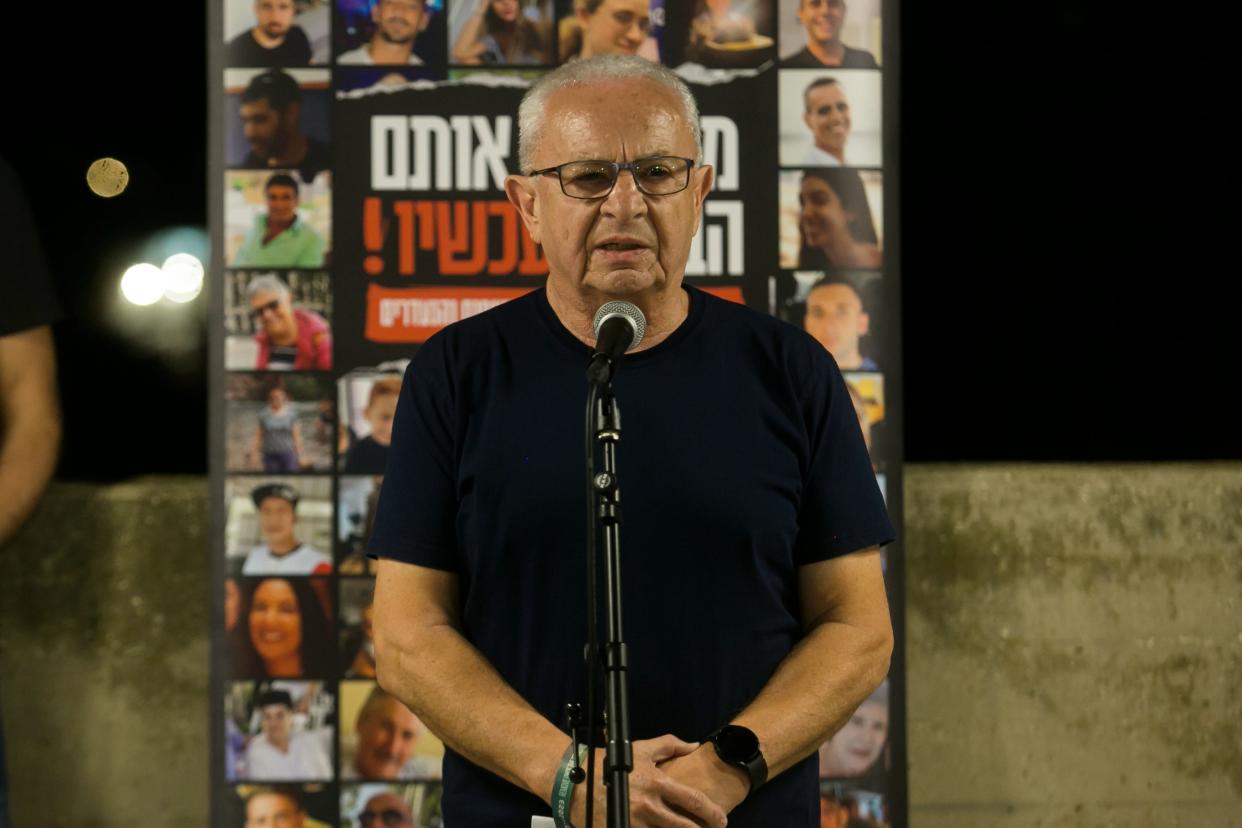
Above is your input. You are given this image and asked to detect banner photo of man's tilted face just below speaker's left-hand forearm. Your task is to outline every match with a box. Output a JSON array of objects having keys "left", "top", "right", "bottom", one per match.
[{"left": 340, "top": 680, "right": 445, "bottom": 782}]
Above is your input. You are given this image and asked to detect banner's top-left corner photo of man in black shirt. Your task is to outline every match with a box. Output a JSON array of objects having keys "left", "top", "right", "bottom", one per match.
[{"left": 224, "top": 0, "right": 330, "bottom": 67}]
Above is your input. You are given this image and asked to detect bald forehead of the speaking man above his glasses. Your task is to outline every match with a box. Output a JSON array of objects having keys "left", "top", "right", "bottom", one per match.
[{"left": 535, "top": 78, "right": 697, "bottom": 166}]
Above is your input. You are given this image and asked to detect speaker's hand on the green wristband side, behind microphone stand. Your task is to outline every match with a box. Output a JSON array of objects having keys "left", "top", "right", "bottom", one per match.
[{"left": 569, "top": 734, "right": 727, "bottom": 828}]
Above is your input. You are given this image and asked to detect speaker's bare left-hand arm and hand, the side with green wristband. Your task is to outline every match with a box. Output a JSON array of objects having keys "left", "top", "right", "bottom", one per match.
[{"left": 375, "top": 559, "right": 725, "bottom": 828}]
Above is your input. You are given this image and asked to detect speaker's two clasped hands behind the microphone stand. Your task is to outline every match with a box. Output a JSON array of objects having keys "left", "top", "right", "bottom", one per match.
[{"left": 569, "top": 734, "right": 750, "bottom": 828}]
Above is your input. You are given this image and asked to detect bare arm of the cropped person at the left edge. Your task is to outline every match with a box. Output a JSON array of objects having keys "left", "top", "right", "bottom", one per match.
[{"left": 0, "top": 325, "right": 61, "bottom": 544}]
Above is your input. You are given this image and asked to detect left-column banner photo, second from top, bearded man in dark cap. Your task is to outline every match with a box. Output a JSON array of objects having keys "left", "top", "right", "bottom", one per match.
[{"left": 225, "top": 68, "right": 332, "bottom": 181}]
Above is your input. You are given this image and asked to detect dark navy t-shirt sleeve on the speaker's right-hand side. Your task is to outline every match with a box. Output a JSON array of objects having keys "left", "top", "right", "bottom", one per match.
[{"left": 794, "top": 351, "right": 895, "bottom": 566}]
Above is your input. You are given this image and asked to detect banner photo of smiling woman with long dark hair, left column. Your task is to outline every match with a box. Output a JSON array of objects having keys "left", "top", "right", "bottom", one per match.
[{"left": 233, "top": 578, "right": 330, "bottom": 678}]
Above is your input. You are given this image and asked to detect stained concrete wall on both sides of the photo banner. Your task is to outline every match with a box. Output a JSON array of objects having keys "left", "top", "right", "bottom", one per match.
[{"left": 0, "top": 464, "right": 1242, "bottom": 828}]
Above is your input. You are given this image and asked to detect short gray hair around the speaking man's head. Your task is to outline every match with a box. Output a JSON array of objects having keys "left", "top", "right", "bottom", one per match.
[{"left": 518, "top": 55, "right": 703, "bottom": 173}]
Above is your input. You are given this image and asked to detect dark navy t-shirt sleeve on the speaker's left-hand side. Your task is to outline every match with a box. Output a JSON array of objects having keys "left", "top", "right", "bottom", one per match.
[{"left": 366, "top": 336, "right": 458, "bottom": 572}]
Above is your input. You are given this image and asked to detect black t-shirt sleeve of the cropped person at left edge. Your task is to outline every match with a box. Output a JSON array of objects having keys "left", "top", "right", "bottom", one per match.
[{"left": 0, "top": 159, "right": 61, "bottom": 336}]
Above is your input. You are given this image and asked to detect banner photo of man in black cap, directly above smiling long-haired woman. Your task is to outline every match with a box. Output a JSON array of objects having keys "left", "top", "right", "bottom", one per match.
[{"left": 225, "top": 475, "right": 333, "bottom": 576}]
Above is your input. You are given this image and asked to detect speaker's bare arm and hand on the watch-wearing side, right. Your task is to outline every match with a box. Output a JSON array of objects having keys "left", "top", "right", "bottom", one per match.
[{"left": 662, "top": 546, "right": 893, "bottom": 811}]
